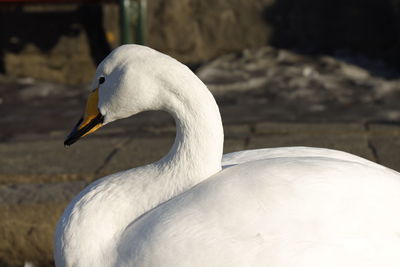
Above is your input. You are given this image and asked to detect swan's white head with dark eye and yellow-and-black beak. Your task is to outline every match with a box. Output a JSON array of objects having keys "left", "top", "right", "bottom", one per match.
[{"left": 64, "top": 45, "right": 186, "bottom": 146}]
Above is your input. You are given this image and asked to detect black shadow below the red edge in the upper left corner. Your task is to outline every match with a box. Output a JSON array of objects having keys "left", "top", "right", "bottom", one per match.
[{"left": 0, "top": 4, "right": 111, "bottom": 73}]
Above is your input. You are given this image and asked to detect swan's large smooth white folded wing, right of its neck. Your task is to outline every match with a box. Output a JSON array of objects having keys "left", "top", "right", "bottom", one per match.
[{"left": 118, "top": 158, "right": 400, "bottom": 267}]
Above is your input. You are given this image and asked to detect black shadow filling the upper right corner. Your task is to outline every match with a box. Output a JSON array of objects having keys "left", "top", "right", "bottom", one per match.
[{"left": 263, "top": 0, "right": 400, "bottom": 78}]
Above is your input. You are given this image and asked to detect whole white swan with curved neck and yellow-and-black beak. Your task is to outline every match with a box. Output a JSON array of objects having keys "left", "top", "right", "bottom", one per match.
[{"left": 55, "top": 45, "right": 400, "bottom": 267}]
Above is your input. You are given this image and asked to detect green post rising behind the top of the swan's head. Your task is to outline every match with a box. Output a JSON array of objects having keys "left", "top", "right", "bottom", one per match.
[{"left": 119, "top": 0, "right": 147, "bottom": 45}]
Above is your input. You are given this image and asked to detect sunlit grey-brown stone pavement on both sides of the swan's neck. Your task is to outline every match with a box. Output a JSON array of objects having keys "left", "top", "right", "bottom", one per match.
[{"left": 0, "top": 122, "right": 400, "bottom": 266}]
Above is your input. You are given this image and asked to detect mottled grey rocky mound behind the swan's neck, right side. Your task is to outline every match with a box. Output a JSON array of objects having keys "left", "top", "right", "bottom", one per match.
[{"left": 196, "top": 47, "right": 400, "bottom": 122}]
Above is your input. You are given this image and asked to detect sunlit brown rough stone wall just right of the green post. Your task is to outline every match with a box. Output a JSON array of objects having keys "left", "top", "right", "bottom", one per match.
[{"left": 149, "top": 0, "right": 274, "bottom": 62}]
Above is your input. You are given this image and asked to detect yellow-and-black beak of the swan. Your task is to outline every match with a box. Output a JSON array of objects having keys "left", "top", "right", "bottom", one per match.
[{"left": 64, "top": 89, "right": 104, "bottom": 146}]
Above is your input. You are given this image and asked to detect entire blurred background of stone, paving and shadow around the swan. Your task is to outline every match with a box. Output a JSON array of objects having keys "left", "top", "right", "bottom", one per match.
[{"left": 0, "top": 0, "right": 400, "bottom": 266}]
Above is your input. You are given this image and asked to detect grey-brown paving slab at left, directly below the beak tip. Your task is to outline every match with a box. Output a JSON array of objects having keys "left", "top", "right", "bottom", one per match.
[{"left": 0, "top": 138, "right": 127, "bottom": 184}]
